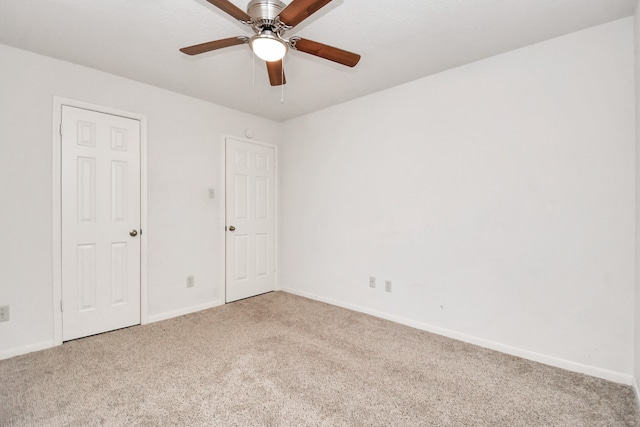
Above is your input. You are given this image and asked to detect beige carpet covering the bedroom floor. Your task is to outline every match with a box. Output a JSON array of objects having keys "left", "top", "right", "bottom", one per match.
[{"left": 0, "top": 292, "right": 640, "bottom": 426}]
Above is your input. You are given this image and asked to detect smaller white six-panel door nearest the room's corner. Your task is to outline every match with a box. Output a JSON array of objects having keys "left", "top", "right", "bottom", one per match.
[{"left": 226, "top": 139, "right": 276, "bottom": 302}]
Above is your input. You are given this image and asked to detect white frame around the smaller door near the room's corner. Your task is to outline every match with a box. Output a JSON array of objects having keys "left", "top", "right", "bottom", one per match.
[{"left": 220, "top": 135, "right": 281, "bottom": 304}]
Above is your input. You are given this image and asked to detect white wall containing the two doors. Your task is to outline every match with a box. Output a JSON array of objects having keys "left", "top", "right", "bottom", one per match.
[{"left": 0, "top": 45, "right": 280, "bottom": 358}]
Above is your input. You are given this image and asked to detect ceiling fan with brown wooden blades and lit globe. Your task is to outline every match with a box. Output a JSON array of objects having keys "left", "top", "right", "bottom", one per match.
[{"left": 180, "top": 0, "right": 360, "bottom": 86}]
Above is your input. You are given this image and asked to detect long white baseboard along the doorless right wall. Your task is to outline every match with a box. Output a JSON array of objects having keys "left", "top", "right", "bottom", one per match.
[{"left": 282, "top": 287, "right": 640, "bottom": 386}]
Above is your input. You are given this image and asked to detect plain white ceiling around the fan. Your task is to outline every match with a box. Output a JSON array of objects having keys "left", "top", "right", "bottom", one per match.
[{"left": 0, "top": 0, "right": 636, "bottom": 121}]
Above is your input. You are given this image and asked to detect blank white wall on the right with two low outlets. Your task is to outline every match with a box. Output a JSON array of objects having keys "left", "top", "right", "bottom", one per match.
[{"left": 281, "top": 18, "right": 635, "bottom": 383}]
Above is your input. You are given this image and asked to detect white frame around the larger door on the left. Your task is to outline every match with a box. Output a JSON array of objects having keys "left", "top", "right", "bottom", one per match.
[{"left": 51, "top": 96, "right": 149, "bottom": 346}]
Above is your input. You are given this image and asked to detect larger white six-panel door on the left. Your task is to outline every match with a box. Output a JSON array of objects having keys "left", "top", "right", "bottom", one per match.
[{"left": 61, "top": 106, "right": 140, "bottom": 341}]
